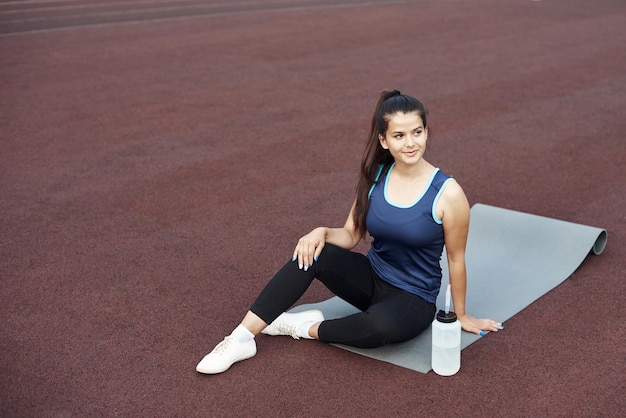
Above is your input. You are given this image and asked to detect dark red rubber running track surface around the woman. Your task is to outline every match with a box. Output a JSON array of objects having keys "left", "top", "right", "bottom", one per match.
[{"left": 0, "top": 0, "right": 626, "bottom": 417}]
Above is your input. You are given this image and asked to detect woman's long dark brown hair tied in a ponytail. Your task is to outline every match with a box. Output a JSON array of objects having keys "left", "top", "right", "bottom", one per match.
[{"left": 354, "top": 90, "right": 427, "bottom": 236}]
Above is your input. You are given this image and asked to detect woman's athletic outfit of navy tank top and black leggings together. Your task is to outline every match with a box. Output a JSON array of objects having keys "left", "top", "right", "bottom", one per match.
[{"left": 250, "top": 165, "right": 452, "bottom": 348}]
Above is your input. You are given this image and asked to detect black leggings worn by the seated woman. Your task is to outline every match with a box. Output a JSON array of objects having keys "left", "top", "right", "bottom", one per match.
[{"left": 250, "top": 244, "right": 435, "bottom": 348}]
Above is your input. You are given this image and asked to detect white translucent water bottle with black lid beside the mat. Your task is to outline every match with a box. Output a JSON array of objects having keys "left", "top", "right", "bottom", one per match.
[{"left": 432, "top": 311, "right": 461, "bottom": 376}]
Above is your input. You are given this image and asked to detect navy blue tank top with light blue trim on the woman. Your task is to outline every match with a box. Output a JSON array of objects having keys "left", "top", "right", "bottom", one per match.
[{"left": 366, "top": 165, "right": 452, "bottom": 303}]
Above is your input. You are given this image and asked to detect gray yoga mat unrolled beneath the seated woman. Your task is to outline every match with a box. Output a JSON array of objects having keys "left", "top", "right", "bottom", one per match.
[{"left": 291, "top": 204, "right": 607, "bottom": 373}]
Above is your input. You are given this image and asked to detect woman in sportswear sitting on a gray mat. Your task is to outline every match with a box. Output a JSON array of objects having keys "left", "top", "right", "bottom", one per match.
[{"left": 196, "top": 90, "right": 503, "bottom": 374}]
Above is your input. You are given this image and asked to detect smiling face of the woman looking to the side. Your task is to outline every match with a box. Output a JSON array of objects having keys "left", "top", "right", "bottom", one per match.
[{"left": 378, "top": 112, "right": 428, "bottom": 165}]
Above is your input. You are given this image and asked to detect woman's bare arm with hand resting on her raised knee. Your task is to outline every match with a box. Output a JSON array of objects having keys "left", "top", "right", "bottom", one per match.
[{"left": 293, "top": 200, "right": 361, "bottom": 270}]
